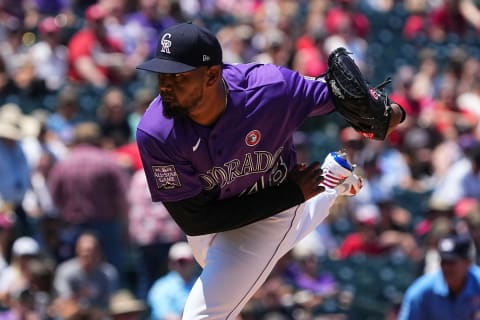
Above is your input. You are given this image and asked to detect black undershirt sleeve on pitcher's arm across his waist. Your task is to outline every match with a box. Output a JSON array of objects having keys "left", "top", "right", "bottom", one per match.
[{"left": 163, "top": 179, "right": 305, "bottom": 236}]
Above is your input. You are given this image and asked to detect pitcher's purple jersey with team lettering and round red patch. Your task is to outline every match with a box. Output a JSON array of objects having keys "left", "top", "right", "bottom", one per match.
[{"left": 137, "top": 64, "right": 334, "bottom": 202}]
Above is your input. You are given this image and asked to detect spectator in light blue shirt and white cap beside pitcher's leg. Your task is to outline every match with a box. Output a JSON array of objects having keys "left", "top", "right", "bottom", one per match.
[{"left": 147, "top": 241, "right": 198, "bottom": 320}]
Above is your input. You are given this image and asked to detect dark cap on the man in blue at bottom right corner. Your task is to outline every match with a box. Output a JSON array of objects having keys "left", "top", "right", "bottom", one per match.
[{"left": 438, "top": 234, "right": 475, "bottom": 260}]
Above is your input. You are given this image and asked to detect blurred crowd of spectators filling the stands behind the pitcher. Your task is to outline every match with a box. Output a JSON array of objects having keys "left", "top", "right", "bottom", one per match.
[{"left": 0, "top": 0, "right": 480, "bottom": 320}]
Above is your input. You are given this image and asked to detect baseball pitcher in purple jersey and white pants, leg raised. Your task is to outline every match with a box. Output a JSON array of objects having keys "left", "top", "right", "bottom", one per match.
[{"left": 137, "top": 23, "right": 404, "bottom": 320}]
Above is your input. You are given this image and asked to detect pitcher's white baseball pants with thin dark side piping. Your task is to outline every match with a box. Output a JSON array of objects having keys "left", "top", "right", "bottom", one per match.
[{"left": 182, "top": 189, "right": 337, "bottom": 320}]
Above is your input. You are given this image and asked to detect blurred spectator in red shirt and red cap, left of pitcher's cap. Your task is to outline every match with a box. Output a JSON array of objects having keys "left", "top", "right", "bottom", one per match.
[{"left": 68, "top": 4, "right": 135, "bottom": 88}]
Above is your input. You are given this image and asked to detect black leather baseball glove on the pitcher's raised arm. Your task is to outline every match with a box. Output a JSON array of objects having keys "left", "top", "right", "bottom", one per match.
[{"left": 325, "top": 47, "right": 400, "bottom": 140}]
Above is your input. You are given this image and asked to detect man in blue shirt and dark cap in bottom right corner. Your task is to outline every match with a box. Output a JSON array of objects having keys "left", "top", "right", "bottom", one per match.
[{"left": 398, "top": 235, "right": 480, "bottom": 320}]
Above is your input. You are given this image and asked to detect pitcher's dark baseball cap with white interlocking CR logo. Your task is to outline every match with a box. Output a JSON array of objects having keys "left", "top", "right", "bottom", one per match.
[{"left": 137, "top": 22, "right": 222, "bottom": 73}]
